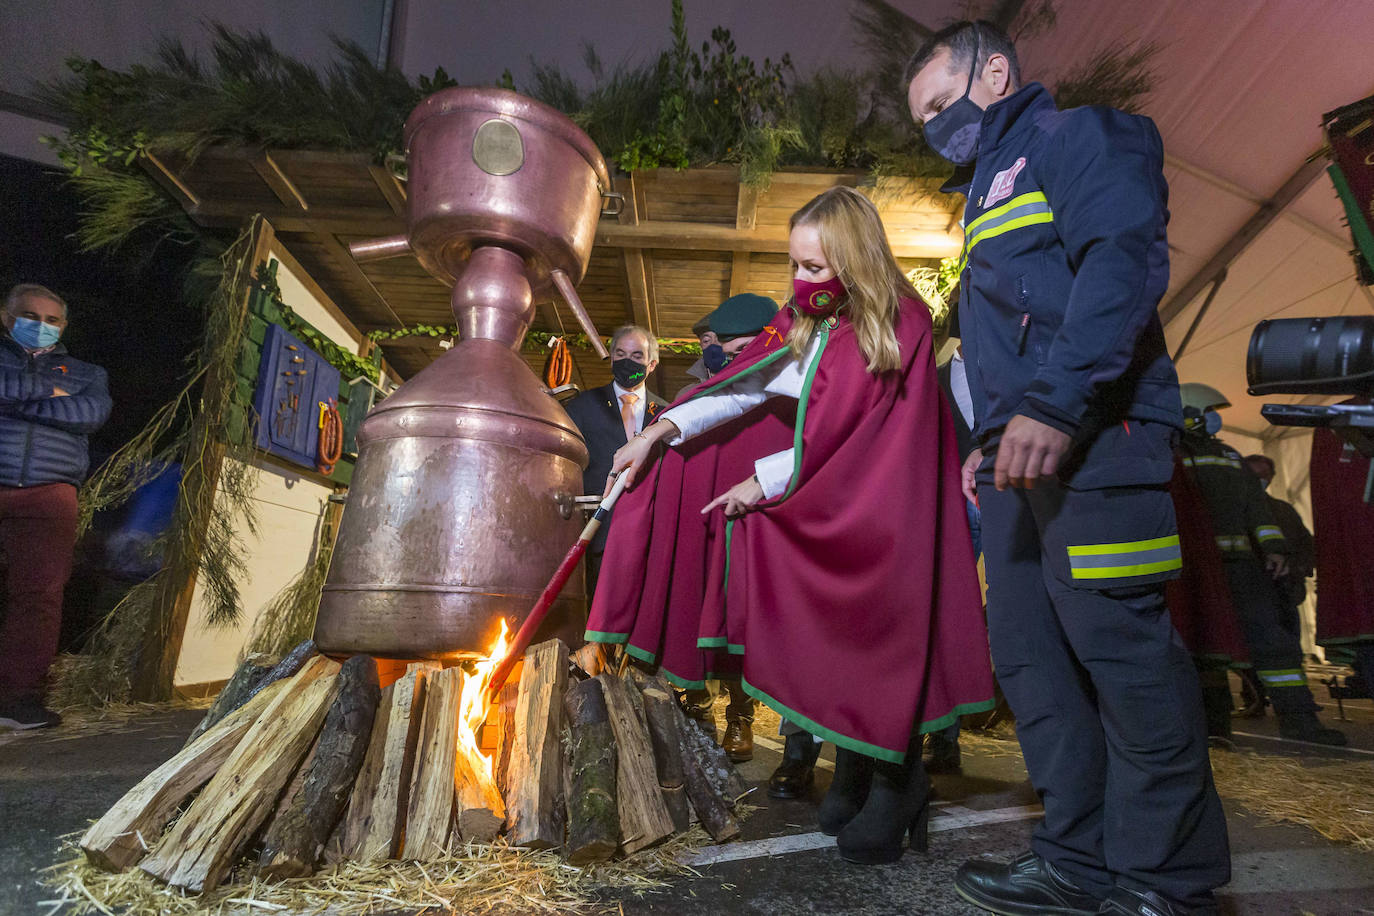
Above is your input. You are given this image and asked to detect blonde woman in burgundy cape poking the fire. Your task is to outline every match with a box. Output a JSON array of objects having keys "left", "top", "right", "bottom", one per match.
[{"left": 587, "top": 187, "right": 992, "bottom": 862}]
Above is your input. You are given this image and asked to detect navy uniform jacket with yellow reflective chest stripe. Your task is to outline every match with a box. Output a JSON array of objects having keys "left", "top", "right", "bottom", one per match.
[{"left": 944, "top": 82, "right": 1183, "bottom": 483}]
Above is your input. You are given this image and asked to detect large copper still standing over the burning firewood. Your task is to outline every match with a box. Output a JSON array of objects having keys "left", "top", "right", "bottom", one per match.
[{"left": 315, "top": 89, "right": 618, "bottom": 659}]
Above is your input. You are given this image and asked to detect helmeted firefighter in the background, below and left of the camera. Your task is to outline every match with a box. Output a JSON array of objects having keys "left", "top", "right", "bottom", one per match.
[{"left": 1183, "top": 383, "right": 1345, "bottom": 744}]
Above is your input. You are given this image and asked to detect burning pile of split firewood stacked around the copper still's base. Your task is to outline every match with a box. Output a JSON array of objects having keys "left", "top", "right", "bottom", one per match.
[{"left": 80, "top": 640, "right": 747, "bottom": 893}]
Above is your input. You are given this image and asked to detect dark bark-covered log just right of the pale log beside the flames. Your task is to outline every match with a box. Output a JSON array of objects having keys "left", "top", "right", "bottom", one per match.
[{"left": 563, "top": 677, "right": 621, "bottom": 865}]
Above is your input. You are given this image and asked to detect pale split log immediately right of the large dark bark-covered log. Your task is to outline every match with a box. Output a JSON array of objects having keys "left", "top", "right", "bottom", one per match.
[{"left": 339, "top": 662, "right": 440, "bottom": 862}]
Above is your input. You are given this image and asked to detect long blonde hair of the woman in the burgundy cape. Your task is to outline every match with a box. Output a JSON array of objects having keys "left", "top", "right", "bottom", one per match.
[{"left": 787, "top": 187, "right": 921, "bottom": 372}]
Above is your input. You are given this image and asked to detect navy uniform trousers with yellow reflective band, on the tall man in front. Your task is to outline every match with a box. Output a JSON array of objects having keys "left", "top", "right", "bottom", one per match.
[{"left": 978, "top": 472, "right": 1231, "bottom": 908}]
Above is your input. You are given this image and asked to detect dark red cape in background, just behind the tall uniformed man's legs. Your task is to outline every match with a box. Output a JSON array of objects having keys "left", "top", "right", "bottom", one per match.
[{"left": 1165, "top": 455, "right": 1249, "bottom": 663}]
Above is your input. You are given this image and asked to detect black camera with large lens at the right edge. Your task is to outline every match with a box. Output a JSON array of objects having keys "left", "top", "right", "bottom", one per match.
[{"left": 1245, "top": 316, "right": 1374, "bottom": 457}]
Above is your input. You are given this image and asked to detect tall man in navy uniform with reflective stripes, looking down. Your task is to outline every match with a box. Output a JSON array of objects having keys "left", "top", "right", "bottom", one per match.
[{"left": 905, "top": 22, "right": 1230, "bottom": 916}]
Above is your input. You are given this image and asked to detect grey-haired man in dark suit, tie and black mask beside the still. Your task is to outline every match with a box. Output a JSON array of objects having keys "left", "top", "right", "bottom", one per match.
[{"left": 563, "top": 324, "right": 668, "bottom": 602}]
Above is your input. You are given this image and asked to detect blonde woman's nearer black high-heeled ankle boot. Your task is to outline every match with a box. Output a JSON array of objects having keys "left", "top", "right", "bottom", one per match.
[{"left": 835, "top": 735, "right": 930, "bottom": 865}]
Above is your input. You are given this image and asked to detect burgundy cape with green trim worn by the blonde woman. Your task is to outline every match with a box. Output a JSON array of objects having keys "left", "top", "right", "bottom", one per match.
[{"left": 587, "top": 299, "right": 992, "bottom": 762}]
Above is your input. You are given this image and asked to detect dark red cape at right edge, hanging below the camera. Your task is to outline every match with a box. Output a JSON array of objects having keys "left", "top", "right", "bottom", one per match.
[{"left": 1312, "top": 420, "right": 1374, "bottom": 647}]
